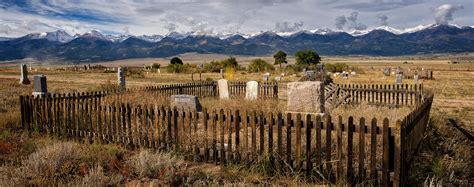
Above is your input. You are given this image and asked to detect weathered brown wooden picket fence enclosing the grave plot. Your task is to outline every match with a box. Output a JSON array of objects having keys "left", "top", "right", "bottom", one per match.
[{"left": 20, "top": 82, "right": 433, "bottom": 186}]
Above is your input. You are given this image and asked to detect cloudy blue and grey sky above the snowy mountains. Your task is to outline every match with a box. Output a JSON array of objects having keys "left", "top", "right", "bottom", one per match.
[{"left": 0, "top": 0, "right": 474, "bottom": 37}]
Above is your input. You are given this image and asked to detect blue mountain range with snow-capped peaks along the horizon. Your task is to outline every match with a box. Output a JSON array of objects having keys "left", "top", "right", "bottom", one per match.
[{"left": 0, "top": 25, "right": 474, "bottom": 63}]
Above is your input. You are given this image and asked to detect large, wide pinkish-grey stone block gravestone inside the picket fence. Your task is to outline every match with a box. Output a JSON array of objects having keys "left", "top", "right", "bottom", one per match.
[{"left": 288, "top": 81, "right": 324, "bottom": 113}]
